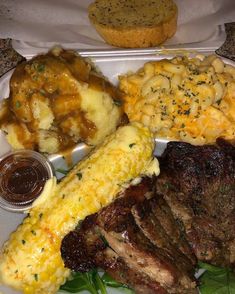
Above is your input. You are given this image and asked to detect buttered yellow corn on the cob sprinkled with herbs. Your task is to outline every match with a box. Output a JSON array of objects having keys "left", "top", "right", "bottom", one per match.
[{"left": 0, "top": 123, "right": 158, "bottom": 294}]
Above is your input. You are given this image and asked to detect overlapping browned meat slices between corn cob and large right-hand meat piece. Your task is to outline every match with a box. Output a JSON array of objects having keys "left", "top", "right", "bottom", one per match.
[{"left": 61, "top": 178, "right": 196, "bottom": 294}]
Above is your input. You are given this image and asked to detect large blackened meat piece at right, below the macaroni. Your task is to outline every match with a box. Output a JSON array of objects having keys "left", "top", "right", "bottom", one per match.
[{"left": 156, "top": 139, "right": 235, "bottom": 266}]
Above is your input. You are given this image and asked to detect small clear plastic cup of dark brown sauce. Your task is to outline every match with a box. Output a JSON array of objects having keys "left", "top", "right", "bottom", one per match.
[{"left": 0, "top": 150, "right": 54, "bottom": 212}]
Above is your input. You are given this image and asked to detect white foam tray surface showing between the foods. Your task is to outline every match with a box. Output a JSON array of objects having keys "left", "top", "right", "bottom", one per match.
[{"left": 0, "top": 48, "right": 232, "bottom": 294}]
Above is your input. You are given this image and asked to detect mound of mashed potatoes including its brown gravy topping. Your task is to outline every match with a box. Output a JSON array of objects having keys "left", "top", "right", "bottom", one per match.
[{"left": 0, "top": 49, "right": 123, "bottom": 153}]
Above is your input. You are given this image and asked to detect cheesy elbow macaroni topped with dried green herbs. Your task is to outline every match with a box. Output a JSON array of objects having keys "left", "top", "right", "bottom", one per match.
[{"left": 119, "top": 55, "right": 235, "bottom": 145}]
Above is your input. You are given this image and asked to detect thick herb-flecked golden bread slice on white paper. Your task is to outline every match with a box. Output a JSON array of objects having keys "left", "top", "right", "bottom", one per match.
[{"left": 88, "top": 0, "right": 178, "bottom": 48}]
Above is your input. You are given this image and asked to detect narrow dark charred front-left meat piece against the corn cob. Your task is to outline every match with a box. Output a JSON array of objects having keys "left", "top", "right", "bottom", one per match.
[{"left": 61, "top": 214, "right": 167, "bottom": 294}]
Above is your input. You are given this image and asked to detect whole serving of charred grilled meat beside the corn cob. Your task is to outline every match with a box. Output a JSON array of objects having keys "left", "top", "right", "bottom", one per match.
[{"left": 61, "top": 140, "right": 235, "bottom": 294}]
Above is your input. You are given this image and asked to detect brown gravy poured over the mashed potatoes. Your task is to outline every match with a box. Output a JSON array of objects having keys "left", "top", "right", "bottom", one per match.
[{"left": 0, "top": 50, "right": 123, "bottom": 152}]
